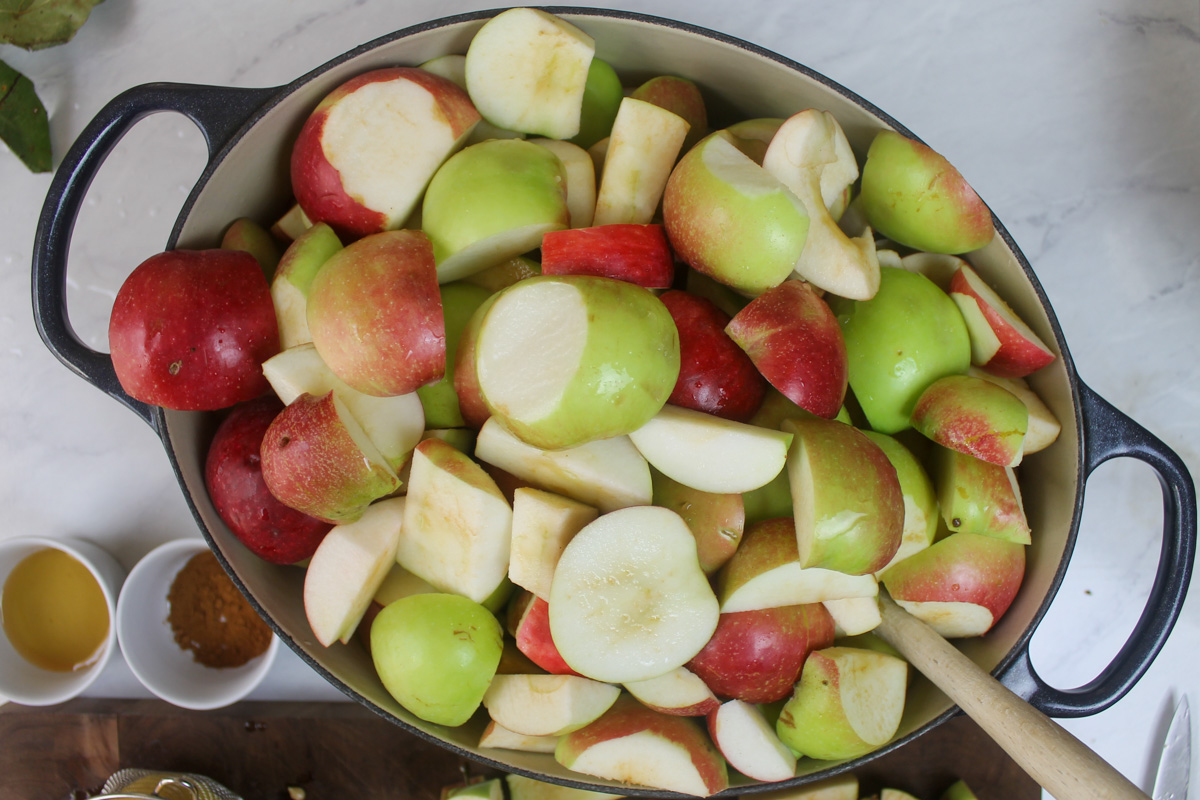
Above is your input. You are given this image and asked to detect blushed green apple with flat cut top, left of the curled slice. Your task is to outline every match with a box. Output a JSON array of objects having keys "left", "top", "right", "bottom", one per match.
[{"left": 662, "top": 131, "right": 809, "bottom": 295}]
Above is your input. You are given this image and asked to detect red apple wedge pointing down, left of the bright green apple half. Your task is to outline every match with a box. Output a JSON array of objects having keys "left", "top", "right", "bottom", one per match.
[{"left": 725, "top": 281, "right": 848, "bottom": 420}]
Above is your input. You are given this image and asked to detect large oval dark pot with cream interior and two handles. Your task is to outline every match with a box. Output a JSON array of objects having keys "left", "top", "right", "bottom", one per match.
[{"left": 34, "top": 8, "right": 1196, "bottom": 795}]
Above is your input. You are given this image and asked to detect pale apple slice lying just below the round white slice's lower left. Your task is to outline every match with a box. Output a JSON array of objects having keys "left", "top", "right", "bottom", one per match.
[{"left": 484, "top": 675, "right": 620, "bottom": 736}]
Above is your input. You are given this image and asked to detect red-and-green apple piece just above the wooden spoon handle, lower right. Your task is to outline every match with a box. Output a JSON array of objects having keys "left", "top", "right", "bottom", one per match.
[{"left": 880, "top": 533, "right": 1025, "bottom": 624}]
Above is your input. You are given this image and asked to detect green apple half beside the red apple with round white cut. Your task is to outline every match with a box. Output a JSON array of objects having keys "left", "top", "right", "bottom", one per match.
[{"left": 421, "top": 139, "right": 570, "bottom": 283}]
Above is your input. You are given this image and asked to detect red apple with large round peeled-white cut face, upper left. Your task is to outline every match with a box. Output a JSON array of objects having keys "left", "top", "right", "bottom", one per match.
[{"left": 292, "top": 67, "right": 479, "bottom": 239}]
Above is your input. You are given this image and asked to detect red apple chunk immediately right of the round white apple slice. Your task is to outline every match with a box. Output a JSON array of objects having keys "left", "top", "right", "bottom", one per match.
[{"left": 688, "top": 603, "right": 834, "bottom": 703}]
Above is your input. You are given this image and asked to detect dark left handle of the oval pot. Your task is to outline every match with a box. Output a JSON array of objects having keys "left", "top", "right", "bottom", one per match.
[{"left": 32, "top": 83, "right": 277, "bottom": 432}]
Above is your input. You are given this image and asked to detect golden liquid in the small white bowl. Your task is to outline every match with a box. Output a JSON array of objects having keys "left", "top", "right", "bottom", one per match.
[{"left": 0, "top": 548, "right": 109, "bottom": 672}]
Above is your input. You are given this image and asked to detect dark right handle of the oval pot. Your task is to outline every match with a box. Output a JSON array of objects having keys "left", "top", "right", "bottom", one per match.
[{"left": 1002, "top": 383, "right": 1196, "bottom": 717}]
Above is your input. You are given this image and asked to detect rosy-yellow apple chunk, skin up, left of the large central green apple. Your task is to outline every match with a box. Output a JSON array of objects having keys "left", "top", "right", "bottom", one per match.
[{"left": 308, "top": 230, "right": 446, "bottom": 397}]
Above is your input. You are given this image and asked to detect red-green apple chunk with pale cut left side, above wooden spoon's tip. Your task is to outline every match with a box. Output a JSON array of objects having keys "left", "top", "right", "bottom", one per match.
[{"left": 784, "top": 416, "right": 905, "bottom": 575}]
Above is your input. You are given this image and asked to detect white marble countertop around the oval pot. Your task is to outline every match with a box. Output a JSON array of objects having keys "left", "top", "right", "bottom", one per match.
[{"left": 0, "top": 0, "right": 1200, "bottom": 789}]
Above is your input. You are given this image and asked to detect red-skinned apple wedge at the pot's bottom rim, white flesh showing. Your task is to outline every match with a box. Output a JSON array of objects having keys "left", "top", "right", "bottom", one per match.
[{"left": 554, "top": 696, "right": 728, "bottom": 796}]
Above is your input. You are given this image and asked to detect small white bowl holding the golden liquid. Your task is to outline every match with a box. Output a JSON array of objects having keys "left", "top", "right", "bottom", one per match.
[{"left": 0, "top": 536, "right": 125, "bottom": 705}]
